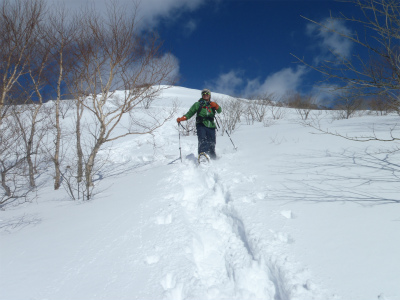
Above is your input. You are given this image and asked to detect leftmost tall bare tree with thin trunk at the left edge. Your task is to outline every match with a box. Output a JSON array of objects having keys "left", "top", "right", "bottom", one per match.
[{"left": 0, "top": 0, "right": 48, "bottom": 187}]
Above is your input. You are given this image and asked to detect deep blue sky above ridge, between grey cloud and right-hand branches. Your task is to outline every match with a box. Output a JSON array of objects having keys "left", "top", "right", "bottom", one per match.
[{"left": 158, "top": 0, "right": 354, "bottom": 94}]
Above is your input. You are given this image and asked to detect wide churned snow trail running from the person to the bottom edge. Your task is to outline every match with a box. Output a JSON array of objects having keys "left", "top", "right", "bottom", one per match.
[{"left": 161, "top": 155, "right": 327, "bottom": 300}]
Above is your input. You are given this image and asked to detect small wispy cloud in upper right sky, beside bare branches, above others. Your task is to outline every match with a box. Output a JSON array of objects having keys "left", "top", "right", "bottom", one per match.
[{"left": 307, "top": 18, "right": 354, "bottom": 63}]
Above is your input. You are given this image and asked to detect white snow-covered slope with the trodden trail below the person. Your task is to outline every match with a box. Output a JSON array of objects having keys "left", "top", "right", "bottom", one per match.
[{"left": 0, "top": 87, "right": 400, "bottom": 300}]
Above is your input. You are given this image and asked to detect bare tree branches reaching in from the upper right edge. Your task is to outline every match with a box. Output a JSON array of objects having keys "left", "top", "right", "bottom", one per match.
[{"left": 294, "top": 0, "right": 400, "bottom": 107}]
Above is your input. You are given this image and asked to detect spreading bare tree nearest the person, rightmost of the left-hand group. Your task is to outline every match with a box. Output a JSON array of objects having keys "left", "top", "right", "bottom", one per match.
[{"left": 70, "top": 2, "right": 175, "bottom": 199}]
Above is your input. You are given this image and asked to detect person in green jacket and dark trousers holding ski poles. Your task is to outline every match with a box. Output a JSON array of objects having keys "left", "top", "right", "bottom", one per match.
[{"left": 176, "top": 89, "right": 222, "bottom": 159}]
